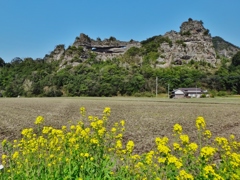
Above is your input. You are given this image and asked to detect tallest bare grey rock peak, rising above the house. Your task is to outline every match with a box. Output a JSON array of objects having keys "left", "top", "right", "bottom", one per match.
[{"left": 158, "top": 19, "right": 217, "bottom": 67}]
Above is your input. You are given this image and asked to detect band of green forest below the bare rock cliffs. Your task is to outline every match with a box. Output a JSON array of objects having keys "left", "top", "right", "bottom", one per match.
[{"left": 0, "top": 50, "right": 240, "bottom": 97}]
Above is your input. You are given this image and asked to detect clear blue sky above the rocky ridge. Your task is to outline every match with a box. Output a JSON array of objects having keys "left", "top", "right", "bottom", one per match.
[{"left": 0, "top": 0, "right": 240, "bottom": 62}]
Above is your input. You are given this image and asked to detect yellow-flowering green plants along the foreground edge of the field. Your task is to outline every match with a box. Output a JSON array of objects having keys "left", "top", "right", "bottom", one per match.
[{"left": 0, "top": 107, "right": 240, "bottom": 180}]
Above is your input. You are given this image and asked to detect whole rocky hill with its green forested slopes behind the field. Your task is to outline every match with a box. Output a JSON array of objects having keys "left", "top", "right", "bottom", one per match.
[{"left": 0, "top": 19, "right": 240, "bottom": 97}]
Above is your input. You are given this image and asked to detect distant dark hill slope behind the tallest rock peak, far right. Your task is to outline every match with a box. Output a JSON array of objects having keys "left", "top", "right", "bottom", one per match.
[{"left": 212, "top": 36, "right": 240, "bottom": 58}]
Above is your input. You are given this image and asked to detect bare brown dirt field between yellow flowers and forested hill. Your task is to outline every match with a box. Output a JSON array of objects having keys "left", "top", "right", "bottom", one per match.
[{"left": 0, "top": 97, "right": 240, "bottom": 154}]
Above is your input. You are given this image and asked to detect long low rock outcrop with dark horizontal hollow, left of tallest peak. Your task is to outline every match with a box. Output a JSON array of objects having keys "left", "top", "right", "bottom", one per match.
[{"left": 44, "top": 33, "right": 141, "bottom": 66}]
